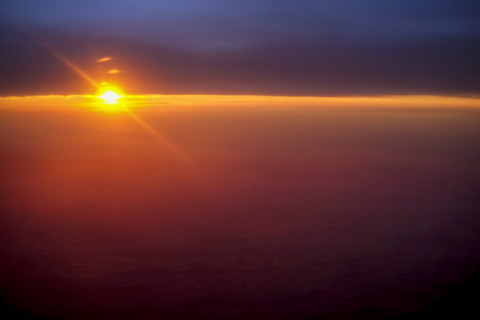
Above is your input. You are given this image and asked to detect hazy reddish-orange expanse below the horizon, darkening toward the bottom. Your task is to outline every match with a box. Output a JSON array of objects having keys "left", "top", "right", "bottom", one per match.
[{"left": 0, "top": 94, "right": 480, "bottom": 320}]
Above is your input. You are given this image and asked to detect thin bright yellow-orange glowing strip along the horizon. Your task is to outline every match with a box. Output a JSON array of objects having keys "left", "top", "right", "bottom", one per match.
[{"left": 0, "top": 94, "right": 480, "bottom": 110}]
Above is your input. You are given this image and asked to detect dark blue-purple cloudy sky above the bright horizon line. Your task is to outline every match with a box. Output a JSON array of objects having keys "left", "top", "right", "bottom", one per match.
[{"left": 0, "top": 0, "right": 480, "bottom": 96}]
